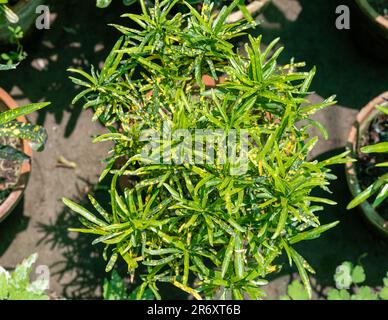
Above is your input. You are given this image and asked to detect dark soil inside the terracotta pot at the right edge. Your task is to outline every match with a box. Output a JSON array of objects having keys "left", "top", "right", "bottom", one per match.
[{"left": 357, "top": 110, "right": 388, "bottom": 220}]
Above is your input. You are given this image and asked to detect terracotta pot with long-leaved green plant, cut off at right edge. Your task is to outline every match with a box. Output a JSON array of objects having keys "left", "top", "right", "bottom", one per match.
[{"left": 346, "top": 92, "right": 388, "bottom": 237}]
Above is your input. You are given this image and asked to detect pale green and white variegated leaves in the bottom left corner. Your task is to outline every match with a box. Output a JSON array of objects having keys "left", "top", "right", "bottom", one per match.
[{"left": 0, "top": 253, "right": 49, "bottom": 300}]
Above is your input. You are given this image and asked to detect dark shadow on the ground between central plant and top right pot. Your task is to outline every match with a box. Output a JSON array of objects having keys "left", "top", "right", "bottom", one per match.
[{"left": 255, "top": 0, "right": 388, "bottom": 109}]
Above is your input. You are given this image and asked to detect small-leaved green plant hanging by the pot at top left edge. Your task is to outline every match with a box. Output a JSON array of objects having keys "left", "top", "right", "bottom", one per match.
[{"left": 0, "top": 0, "right": 27, "bottom": 66}]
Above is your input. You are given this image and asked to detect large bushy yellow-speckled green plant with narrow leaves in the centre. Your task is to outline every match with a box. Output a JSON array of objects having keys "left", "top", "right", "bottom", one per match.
[{"left": 63, "top": 0, "right": 349, "bottom": 299}]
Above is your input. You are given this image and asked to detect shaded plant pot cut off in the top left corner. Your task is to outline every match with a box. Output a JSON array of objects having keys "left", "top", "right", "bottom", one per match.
[{"left": 0, "top": 0, "right": 45, "bottom": 46}]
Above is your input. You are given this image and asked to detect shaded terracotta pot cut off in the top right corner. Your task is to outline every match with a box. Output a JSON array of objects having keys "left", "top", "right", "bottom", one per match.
[{"left": 351, "top": 0, "right": 388, "bottom": 61}]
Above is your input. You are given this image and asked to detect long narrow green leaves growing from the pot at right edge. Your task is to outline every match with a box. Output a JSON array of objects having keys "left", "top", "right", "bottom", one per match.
[{"left": 347, "top": 106, "right": 388, "bottom": 209}]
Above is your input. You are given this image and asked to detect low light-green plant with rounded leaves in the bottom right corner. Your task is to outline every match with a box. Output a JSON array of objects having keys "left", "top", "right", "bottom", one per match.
[{"left": 280, "top": 261, "right": 388, "bottom": 300}]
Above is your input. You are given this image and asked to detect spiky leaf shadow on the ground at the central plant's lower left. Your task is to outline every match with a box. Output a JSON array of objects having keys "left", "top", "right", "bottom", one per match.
[{"left": 37, "top": 179, "right": 109, "bottom": 299}]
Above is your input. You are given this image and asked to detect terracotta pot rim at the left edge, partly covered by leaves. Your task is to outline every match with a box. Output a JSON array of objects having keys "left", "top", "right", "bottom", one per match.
[{"left": 0, "top": 88, "right": 32, "bottom": 222}]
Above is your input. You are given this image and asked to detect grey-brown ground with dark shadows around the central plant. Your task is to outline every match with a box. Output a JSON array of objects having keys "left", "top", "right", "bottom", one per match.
[{"left": 0, "top": 0, "right": 388, "bottom": 298}]
